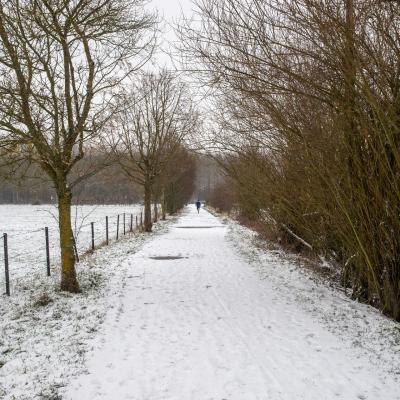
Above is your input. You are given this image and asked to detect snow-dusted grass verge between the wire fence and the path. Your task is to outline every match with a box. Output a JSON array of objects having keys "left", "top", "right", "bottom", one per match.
[{"left": 0, "top": 216, "right": 175, "bottom": 400}]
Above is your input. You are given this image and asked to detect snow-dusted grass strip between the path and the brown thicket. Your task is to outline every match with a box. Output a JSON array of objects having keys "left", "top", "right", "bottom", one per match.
[{"left": 224, "top": 217, "right": 400, "bottom": 378}]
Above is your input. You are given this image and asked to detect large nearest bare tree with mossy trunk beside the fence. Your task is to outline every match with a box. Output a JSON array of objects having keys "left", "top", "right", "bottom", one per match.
[{"left": 0, "top": 0, "right": 154, "bottom": 292}]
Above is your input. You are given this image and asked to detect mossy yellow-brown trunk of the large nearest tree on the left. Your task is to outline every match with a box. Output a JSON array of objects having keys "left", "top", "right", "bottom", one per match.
[{"left": 58, "top": 186, "right": 80, "bottom": 293}]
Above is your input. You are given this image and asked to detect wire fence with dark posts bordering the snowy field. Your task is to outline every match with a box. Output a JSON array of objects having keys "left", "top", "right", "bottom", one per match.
[{"left": 0, "top": 212, "right": 143, "bottom": 296}]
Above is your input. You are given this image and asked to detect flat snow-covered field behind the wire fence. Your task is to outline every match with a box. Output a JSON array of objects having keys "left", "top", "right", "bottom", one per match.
[{"left": 0, "top": 205, "right": 142, "bottom": 293}]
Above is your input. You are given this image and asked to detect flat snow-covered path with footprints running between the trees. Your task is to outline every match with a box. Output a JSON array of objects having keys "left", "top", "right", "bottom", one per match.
[{"left": 63, "top": 208, "right": 400, "bottom": 400}]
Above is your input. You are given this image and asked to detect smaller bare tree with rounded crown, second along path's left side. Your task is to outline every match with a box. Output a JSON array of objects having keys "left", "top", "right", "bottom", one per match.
[{"left": 110, "top": 71, "right": 197, "bottom": 232}]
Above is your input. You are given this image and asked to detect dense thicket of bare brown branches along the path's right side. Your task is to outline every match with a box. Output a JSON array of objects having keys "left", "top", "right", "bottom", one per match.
[{"left": 179, "top": 0, "right": 400, "bottom": 320}]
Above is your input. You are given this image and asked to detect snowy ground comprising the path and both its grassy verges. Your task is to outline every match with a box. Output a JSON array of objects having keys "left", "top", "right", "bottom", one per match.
[{"left": 0, "top": 207, "right": 400, "bottom": 400}]
